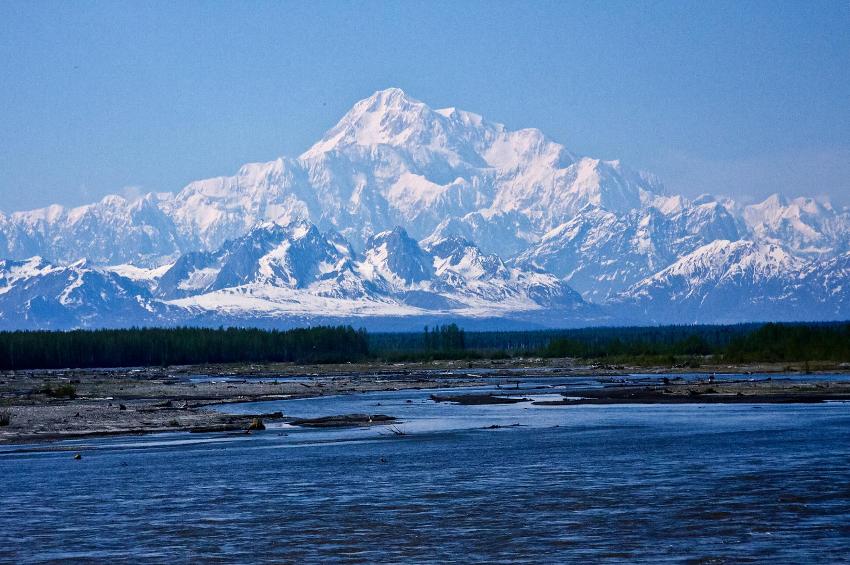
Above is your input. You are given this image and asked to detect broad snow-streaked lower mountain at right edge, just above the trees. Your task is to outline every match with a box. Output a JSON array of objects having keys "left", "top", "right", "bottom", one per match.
[{"left": 616, "top": 241, "right": 850, "bottom": 323}]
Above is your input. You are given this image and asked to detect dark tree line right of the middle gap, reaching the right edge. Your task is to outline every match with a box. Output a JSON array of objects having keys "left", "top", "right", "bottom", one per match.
[{"left": 369, "top": 323, "right": 850, "bottom": 362}]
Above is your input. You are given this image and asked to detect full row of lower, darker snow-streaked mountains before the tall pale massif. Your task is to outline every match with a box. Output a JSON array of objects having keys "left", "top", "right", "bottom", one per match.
[{"left": 0, "top": 216, "right": 836, "bottom": 328}]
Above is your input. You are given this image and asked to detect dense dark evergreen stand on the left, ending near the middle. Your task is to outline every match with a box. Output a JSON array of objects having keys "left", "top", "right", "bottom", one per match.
[{"left": 0, "top": 326, "right": 369, "bottom": 370}]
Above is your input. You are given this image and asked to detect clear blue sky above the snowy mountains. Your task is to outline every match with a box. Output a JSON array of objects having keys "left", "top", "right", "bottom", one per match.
[{"left": 0, "top": 0, "right": 850, "bottom": 212}]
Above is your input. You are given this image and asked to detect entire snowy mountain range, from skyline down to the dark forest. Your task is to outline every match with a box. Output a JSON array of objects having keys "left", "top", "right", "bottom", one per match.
[{"left": 0, "top": 89, "right": 850, "bottom": 328}]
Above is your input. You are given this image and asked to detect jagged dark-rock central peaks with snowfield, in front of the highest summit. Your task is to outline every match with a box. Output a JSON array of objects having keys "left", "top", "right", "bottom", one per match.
[{"left": 155, "top": 222, "right": 600, "bottom": 327}]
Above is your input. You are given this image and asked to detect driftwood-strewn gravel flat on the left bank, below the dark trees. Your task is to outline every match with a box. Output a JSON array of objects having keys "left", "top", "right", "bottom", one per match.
[{"left": 0, "top": 365, "right": 490, "bottom": 443}]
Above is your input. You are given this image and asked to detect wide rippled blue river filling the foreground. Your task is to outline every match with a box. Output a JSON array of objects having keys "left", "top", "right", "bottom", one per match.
[{"left": 0, "top": 376, "right": 850, "bottom": 563}]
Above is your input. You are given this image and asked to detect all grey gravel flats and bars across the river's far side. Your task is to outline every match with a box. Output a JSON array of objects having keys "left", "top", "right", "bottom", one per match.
[{"left": 0, "top": 359, "right": 850, "bottom": 443}]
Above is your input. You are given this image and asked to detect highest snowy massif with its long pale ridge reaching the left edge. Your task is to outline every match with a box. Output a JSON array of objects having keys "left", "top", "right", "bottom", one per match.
[{"left": 0, "top": 89, "right": 658, "bottom": 263}]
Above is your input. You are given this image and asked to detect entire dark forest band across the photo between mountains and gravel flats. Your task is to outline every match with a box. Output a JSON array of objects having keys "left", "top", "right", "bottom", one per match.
[{"left": 0, "top": 323, "right": 850, "bottom": 371}]
